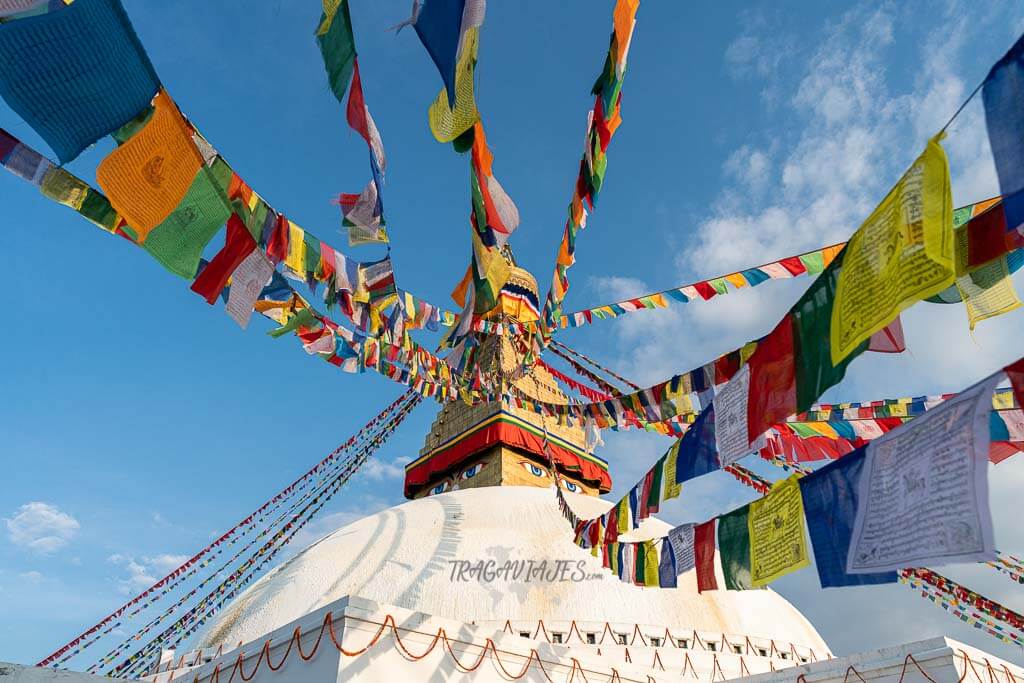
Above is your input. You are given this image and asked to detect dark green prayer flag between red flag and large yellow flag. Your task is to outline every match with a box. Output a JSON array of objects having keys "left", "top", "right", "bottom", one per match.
[{"left": 791, "top": 249, "right": 868, "bottom": 412}]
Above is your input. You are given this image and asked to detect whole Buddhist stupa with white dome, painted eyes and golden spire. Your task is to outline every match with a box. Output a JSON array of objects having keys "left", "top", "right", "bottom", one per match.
[{"left": 8, "top": 259, "right": 1024, "bottom": 683}]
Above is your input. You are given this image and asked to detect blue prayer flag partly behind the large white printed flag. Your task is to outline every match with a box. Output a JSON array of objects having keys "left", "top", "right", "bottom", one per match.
[{"left": 800, "top": 448, "right": 896, "bottom": 588}]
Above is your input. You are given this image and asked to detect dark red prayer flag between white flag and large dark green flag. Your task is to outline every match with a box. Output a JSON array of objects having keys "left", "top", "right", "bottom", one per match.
[{"left": 746, "top": 313, "right": 797, "bottom": 443}]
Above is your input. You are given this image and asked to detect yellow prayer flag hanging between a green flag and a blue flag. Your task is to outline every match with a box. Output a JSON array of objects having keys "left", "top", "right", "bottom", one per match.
[{"left": 746, "top": 475, "right": 810, "bottom": 587}]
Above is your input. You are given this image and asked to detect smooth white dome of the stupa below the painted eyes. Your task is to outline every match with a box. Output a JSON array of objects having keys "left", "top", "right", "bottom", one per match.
[{"left": 199, "top": 486, "right": 828, "bottom": 658}]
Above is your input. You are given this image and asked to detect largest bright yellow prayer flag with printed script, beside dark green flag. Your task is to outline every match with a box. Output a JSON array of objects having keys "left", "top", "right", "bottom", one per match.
[{"left": 831, "top": 133, "right": 953, "bottom": 365}]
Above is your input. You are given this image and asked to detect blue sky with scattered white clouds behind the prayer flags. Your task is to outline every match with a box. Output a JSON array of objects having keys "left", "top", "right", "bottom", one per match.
[{"left": 0, "top": 0, "right": 1024, "bottom": 663}]
